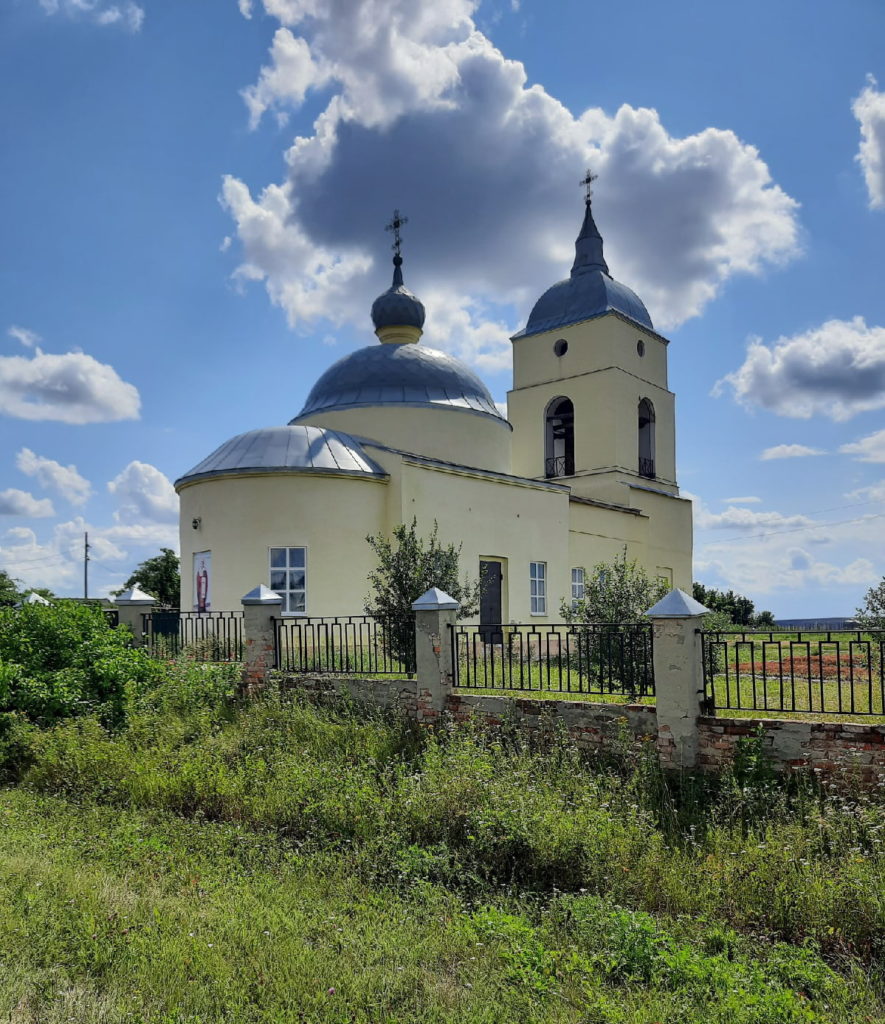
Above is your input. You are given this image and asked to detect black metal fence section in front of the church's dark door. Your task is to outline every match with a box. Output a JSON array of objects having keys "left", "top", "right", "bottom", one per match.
[{"left": 451, "top": 623, "right": 655, "bottom": 700}]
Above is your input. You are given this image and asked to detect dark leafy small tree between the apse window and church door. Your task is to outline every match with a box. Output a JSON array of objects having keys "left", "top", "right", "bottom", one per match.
[{"left": 366, "top": 519, "right": 479, "bottom": 671}]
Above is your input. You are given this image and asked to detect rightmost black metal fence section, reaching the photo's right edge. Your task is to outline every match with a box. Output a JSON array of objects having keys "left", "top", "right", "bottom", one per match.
[{"left": 702, "top": 630, "right": 885, "bottom": 716}]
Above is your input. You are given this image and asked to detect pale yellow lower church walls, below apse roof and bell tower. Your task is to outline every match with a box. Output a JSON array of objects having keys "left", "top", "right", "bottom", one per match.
[{"left": 180, "top": 456, "right": 691, "bottom": 622}]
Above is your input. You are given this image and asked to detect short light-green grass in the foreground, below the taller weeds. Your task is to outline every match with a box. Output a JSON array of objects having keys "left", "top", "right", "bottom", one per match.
[{"left": 0, "top": 792, "right": 881, "bottom": 1024}]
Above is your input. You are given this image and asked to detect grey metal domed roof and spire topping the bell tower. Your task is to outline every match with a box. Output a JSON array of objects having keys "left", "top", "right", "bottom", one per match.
[{"left": 513, "top": 197, "right": 654, "bottom": 338}]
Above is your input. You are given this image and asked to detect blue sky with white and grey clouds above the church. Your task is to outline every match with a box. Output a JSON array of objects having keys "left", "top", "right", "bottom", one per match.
[{"left": 0, "top": 0, "right": 885, "bottom": 615}]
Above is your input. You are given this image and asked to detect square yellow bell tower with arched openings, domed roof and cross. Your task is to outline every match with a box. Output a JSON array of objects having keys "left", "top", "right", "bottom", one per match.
[{"left": 507, "top": 178, "right": 679, "bottom": 506}]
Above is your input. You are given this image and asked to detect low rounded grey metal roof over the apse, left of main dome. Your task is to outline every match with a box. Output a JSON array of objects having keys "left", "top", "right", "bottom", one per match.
[{"left": 175, "top": 425, "right": 387, "bottom": 487}]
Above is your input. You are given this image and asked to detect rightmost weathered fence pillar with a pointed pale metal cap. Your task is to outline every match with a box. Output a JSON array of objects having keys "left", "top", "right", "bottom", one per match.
[{"left": 645, "top": 590, "right": 710, "bottom": 768}]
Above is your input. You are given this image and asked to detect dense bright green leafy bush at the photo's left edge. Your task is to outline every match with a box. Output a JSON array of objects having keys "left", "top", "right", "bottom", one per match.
[{"left": 0, "top": 602, "right": 162, "bottom": 727}]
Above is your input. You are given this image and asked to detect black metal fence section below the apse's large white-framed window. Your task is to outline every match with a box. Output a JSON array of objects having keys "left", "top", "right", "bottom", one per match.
[{"left": 275, "top": 615, "right": 415, "bottom": 676}]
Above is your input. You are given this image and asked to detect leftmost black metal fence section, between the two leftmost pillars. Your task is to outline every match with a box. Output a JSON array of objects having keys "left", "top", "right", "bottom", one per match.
[{"left": 141, "top": 611, "right": 243, "bottom": 662}]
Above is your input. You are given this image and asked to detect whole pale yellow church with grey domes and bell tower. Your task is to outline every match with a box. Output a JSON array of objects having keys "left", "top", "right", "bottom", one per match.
[{"left": 175, "top": 195, "right": 691, "bottom": 623}]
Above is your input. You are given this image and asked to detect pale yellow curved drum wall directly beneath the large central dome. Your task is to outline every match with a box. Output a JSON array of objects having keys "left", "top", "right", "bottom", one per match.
[{"left": 290, "top": 404, "right": 511, "bottom": 473}]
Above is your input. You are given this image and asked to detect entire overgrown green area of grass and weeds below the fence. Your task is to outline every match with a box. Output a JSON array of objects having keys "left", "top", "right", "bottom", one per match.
[{"left": 0, "top": 665, "right": 885, "bottom": 1024}]
